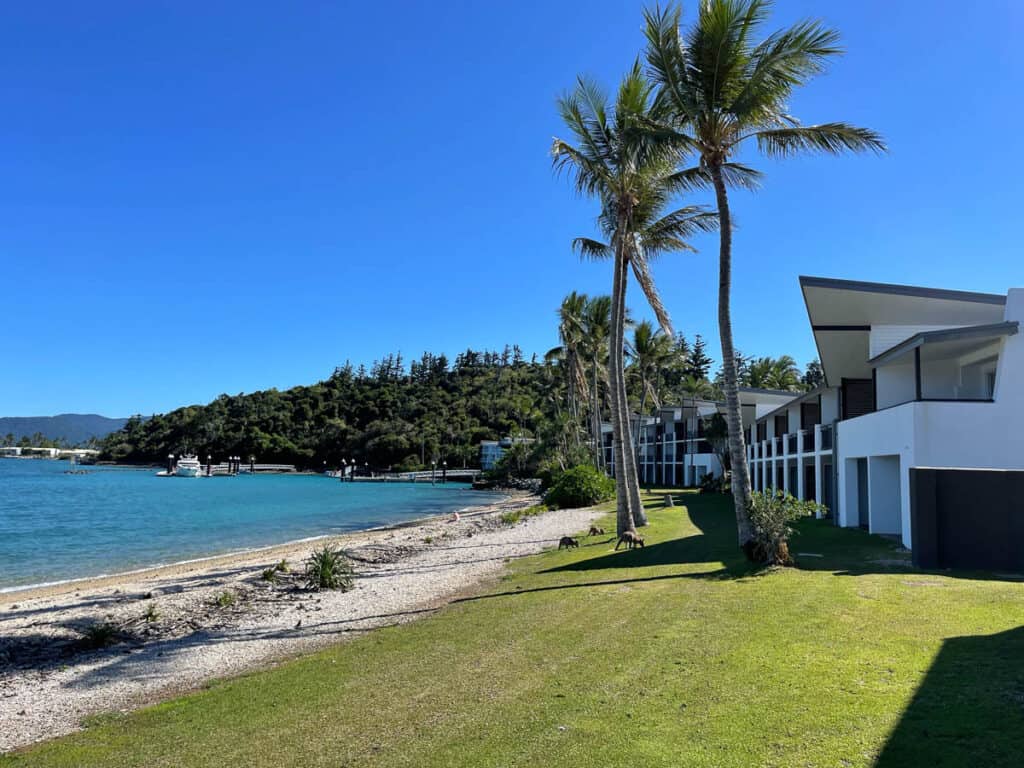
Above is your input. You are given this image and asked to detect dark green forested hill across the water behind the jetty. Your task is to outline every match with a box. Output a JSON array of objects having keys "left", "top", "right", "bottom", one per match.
[{"left": 103, "top": 347, "right": 559, "bottom": 468}]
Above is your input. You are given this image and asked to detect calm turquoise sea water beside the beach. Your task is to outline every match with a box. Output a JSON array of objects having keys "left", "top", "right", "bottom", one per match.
[{"left": 0, "top": 459, "right": 498, "bottom": 590}]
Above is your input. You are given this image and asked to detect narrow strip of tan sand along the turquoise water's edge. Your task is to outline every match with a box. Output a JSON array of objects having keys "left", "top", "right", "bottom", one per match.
[{"left": 0, "top": 495, "right": 516, "bottom": 607}]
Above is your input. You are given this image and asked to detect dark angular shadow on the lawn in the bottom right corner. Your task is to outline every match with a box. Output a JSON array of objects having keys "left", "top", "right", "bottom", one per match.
[{"left": 874, "top": 627, "right": 1024, "bottom": 768}]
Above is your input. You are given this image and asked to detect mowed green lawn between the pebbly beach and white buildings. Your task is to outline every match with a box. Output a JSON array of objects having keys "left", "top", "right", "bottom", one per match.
[{"left": 6, "top": 494, "right": 1024, "bottom": 768}]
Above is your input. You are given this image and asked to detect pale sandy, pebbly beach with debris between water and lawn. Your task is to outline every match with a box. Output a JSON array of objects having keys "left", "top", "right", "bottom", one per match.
[{"left": 0, "top": 495, "right": 599, "bottom": 752}]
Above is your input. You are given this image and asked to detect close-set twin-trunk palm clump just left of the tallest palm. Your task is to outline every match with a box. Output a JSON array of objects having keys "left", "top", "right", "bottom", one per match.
[{"left": 552, "top": 61, "right": 714, "bottom": 532}]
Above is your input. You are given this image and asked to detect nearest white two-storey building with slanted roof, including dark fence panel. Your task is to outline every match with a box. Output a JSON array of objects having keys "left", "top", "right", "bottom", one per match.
[{"left": 746, "top": 278, "right": 1024, "bottom": 568}]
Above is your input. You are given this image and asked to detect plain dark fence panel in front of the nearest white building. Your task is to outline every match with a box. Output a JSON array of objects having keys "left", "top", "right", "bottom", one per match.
[{"left": 910, "top": 468, "right": 1024, "bottom": 572}]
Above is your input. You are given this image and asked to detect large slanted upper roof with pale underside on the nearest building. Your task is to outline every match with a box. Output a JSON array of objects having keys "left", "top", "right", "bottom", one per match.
[{"left": 800, "top": 275, "right": 1007, "bottom": 385}]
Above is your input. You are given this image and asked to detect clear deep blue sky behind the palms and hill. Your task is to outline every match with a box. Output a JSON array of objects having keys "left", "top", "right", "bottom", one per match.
[{"left": 0, "top": 0, "right": 1024, "bottom": 416}]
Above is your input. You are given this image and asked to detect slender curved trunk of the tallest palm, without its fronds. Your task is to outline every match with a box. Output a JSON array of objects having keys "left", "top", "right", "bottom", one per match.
[{"left": 711, "top": 163, "right": 754, "bottom": 547}]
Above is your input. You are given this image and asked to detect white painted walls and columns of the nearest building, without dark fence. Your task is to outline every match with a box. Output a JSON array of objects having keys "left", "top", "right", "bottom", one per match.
[{"left": 749, "top": 279, "right": 1024, "bottom": 548}]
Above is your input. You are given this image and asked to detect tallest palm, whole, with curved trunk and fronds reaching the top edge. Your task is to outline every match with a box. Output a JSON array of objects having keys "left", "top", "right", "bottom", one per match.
[{"left": 644, "top": 0, "right": 885, "bottom": 547}]
